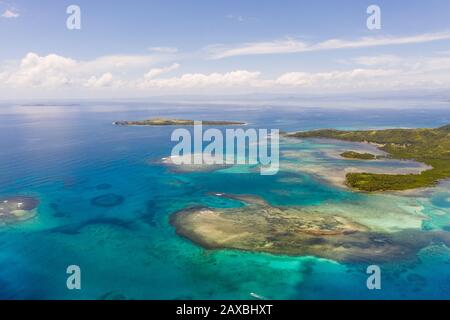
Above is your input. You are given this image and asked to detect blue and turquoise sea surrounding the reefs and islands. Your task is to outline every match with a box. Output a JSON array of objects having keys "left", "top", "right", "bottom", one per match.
[{"left": 0, "top": 103, "right": 450, "bottom": 299}]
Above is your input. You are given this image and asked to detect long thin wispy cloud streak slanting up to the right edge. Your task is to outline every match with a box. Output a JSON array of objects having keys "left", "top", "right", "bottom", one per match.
[{"left": 206, "top": 31, "right": 450, "bottom": 59}]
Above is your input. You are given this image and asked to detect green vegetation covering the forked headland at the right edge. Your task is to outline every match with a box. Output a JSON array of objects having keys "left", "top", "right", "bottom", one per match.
[{"left": 289, "top": 125, "right": 450, "bottom": 192}]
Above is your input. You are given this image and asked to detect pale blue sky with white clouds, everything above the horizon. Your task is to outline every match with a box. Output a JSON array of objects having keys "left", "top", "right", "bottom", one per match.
[{"left": 0, "top": 0, "right": 450, "bottom": 99}]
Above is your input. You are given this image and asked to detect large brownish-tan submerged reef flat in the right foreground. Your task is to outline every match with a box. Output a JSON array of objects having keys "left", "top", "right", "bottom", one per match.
[{"left": 171, "top": 196, "right": 450, "bottom": 262}]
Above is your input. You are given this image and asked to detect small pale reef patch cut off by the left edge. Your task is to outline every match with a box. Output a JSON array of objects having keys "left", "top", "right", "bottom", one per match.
[{"left": 0, "top": 196, "right": 39, "bottom": 226}]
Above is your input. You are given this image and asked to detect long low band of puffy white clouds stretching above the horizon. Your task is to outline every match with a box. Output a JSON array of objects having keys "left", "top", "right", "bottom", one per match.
[{"left": 0, "top": 53, "right": 450, "bottom": 95}]
